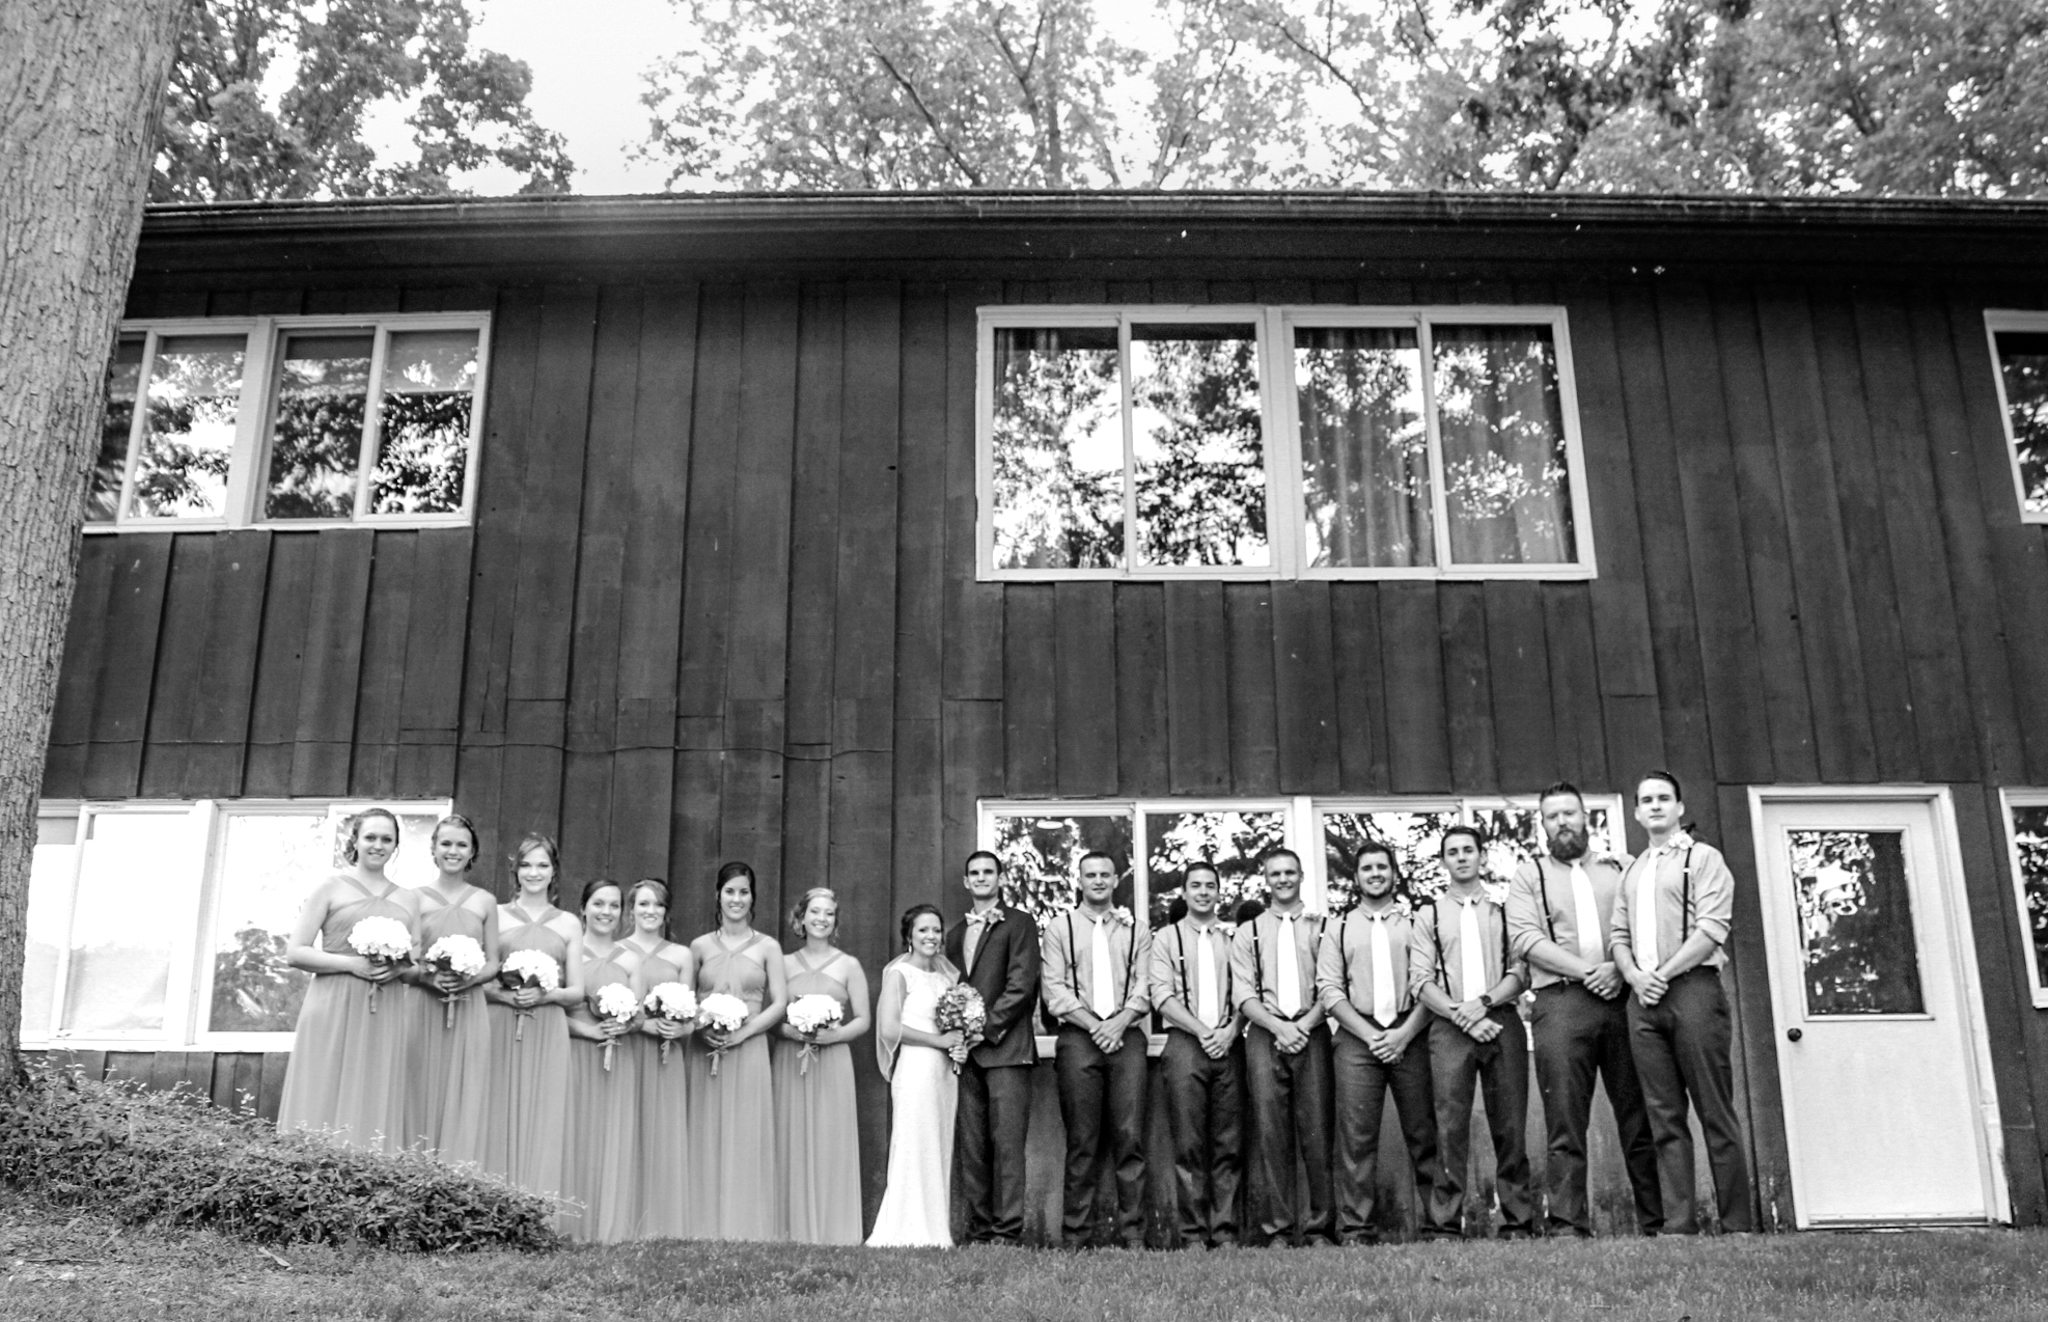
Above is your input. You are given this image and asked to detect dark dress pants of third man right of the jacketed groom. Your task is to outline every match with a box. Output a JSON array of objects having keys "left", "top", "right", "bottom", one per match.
[{"left": 1245, "top": 1023, "right": 1337, "bottom": 1240}]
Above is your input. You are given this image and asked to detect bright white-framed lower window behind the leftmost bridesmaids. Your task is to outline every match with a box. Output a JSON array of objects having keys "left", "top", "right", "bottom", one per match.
[{"left": 20, "top": 800, "right": 449, "bottom": 1052}]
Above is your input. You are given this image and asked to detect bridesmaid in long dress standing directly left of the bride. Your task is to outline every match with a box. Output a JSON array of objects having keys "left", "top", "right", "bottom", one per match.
[{"left": 772, "top": 886, "right": 870, "bottom": 1244}]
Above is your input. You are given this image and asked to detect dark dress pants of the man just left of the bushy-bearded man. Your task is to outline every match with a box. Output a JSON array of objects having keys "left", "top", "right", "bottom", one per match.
[{"left": 1423, "top": 1005, "right": 1536, "bottom": 1236}]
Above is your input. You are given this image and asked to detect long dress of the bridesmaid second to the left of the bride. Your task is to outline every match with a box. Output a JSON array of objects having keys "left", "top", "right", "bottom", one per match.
[{"left": 690, "top": 933, "right": 782, "bottom": 1240}]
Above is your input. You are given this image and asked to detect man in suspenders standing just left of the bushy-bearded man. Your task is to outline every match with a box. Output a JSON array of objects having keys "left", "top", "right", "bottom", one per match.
[{"left": 1409, "top": 827, "right": 1534, "bottom": 1240}]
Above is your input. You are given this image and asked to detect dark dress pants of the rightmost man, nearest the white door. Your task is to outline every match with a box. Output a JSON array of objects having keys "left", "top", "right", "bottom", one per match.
[{"left": 1628, "top": 968, "right": 1757, "bottom": 1234}]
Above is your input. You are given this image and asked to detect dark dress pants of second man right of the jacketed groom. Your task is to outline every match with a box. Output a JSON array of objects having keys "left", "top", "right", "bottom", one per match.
[{"left": 1159, "top": 1027, "right": 1245, "bottom": 1248}]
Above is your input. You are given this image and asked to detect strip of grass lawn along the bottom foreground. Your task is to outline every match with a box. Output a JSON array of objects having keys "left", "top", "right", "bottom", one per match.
[{"left": 0, "top": 1201, "right": 2048, "bottom": 1322}]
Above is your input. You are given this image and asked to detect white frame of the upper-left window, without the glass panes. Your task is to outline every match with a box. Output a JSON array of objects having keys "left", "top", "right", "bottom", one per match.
[{"left": 84, "top": 311, "right": 492, "bottom": 536}]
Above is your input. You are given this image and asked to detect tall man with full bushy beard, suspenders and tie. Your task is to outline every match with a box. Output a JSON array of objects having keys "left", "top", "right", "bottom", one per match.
[{"left": 1507, "top": 782, "right": 1663, "bottom": 1238}]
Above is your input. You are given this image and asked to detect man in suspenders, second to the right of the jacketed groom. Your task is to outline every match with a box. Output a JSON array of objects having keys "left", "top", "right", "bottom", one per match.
[{"left": 1151, "top": 860, "right": 1245, "bottom": 1248}]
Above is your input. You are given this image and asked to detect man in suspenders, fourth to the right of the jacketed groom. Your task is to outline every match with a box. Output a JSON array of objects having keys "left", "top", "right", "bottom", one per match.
[{"left": 1315, "top": 841, "right": 1438, "bottom": 1244}]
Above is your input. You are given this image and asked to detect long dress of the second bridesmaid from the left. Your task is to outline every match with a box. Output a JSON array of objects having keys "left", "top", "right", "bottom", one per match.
[{"left": 406, "top": 890, "right": 492, "bottom": 1162}]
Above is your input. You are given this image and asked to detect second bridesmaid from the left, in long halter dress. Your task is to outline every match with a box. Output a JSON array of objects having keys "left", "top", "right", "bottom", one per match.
[{"left": 406, "top": 814, "right": 498, "bottom": 1164}]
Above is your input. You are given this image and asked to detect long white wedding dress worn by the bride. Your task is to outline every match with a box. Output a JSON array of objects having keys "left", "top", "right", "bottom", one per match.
[{"left": 868, "top": 964, "right": 961, "bottom": 1246}]
